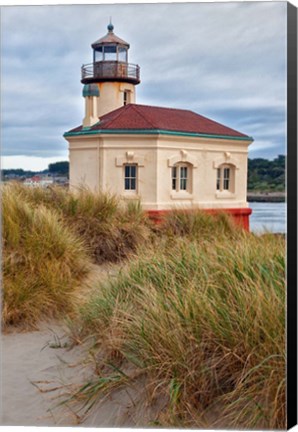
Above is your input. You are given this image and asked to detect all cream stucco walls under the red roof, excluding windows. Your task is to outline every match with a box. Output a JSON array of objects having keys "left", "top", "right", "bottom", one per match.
[{"left": 67, "top": 135, "right": 250, "bottom": 210}]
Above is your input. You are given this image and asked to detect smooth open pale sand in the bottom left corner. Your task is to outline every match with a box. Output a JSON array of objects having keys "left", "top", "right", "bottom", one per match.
[{"left": 1, "top": 323, "right": 91, "bottom": 426}]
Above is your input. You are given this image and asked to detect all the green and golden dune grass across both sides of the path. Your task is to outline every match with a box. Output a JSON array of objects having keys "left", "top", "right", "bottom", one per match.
[{"left": 2, "top": 184, "right": 286, "bottom": 429}]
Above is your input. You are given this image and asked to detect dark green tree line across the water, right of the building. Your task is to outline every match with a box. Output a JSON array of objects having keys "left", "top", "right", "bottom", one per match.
[{"left": 248, "top": 155, "right": 286, "bottom": 192}]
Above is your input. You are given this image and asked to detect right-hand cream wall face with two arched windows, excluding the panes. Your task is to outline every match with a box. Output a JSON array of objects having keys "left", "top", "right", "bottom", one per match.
[{"left": 157, "top": 136, "right": 248, "bottom": 209}]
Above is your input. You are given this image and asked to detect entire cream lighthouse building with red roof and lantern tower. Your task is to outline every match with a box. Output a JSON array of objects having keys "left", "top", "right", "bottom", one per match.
[{"left": 64, "top": 24, "right": 253, "bottom": 227}]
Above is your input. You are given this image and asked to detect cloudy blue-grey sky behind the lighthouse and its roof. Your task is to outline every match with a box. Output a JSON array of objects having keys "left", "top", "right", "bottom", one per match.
[{"left": 1, "top": 2, "right": 286, "bottom": 169}]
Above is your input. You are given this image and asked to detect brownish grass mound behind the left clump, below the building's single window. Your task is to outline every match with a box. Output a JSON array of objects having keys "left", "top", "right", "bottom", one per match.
[{"left": 10, "top": 184, "right": 150, "bottom": 264}]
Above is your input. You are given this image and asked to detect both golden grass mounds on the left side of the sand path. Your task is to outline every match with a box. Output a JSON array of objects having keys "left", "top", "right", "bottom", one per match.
[{"left": 1, "top": 183, "right": 151, "bottom": 326}]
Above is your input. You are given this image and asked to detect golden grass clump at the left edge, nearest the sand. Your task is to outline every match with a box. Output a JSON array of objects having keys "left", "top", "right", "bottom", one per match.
[{"left": 2, "top": 186, "right": 90, "bottom": 327}]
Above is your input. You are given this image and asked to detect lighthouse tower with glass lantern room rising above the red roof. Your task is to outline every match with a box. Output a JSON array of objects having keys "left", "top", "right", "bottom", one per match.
[{"left": 81, "top": 22, "right": 140, "bottom": 128}]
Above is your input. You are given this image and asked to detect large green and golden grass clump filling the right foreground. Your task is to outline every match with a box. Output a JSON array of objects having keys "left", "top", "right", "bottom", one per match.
[{"left": 76, "top": 233, "right": 286, "bottom": 429}]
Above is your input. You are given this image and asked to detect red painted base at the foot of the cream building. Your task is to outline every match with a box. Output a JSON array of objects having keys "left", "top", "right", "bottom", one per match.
[{"left": 147, "top": 207, "right": 252, "bottom": 231}]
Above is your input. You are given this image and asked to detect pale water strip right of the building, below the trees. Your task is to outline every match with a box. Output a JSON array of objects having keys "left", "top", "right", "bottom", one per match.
[{"left": 249, "top": 202, "right": 286, "bottom": 233}]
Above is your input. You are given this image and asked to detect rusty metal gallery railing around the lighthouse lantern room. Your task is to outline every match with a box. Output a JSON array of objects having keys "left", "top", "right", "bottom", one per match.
[{"left": 82, "top": 61, "right": 140, "bottom": 83}]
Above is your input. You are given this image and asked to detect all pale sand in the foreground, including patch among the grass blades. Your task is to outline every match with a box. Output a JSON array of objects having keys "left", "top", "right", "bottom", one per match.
[{"left": 1, "top": 322, "right": 165, "bottom": 427}]
